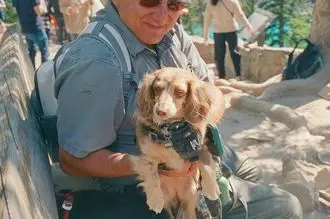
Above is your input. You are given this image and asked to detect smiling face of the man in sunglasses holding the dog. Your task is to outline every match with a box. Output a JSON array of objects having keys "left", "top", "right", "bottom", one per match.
[{"left": 113, "top": 0, "right": 183, "bottom": 45}]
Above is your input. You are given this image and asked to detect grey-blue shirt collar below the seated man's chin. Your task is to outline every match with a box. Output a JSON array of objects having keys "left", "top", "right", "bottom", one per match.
[{"left": 105, "top": 3, "right": 174, "bottom": 56}]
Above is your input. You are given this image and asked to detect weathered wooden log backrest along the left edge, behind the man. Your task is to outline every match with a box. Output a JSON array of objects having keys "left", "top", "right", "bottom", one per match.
[{"left": 0, "top": 25, "right": 58, "bottom": 219}]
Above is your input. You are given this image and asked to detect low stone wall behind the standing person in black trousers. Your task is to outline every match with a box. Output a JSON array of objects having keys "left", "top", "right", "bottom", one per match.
[{"left": 192, "top": 36, "right": 301, "bottom": 82}]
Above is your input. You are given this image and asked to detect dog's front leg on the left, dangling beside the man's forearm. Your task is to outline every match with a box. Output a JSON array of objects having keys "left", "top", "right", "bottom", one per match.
[{"left": 131, "top": 156, "right": 164, "bottom": 214}]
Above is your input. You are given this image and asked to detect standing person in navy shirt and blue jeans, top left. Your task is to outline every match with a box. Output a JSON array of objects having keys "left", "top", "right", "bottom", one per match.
[{"left": 13, "top": 0, "right": 48, "bottom": 68}]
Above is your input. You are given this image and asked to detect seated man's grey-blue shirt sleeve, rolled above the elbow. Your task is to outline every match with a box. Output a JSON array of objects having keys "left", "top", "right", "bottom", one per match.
[{"left": 55, "top": 51, "right": 124, "bottom": 158}]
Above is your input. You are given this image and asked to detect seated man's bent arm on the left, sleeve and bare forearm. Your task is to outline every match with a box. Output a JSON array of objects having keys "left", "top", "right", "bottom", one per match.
[{"left": 55, "top": 38, "right": 133, "bottom": 177}]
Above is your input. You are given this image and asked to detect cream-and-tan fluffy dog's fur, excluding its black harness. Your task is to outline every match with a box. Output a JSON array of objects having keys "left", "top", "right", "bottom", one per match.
[{"left": 131, "top": 68, "right": 223, "bottom": 219}]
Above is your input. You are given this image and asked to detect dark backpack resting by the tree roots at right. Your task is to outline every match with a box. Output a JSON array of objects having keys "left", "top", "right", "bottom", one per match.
[{"left": 282, "top": 39, "right": 324, "bottom": 80}]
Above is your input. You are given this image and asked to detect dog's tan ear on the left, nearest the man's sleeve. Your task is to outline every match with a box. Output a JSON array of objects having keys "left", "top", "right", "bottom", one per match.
[{"left": 137, "top": 72, "right": 158, "bottom": 118}]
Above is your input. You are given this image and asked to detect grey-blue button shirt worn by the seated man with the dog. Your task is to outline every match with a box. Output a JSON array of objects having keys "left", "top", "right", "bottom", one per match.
[{"left": 55, "top": 4, "right": 213, "bottom": 187}]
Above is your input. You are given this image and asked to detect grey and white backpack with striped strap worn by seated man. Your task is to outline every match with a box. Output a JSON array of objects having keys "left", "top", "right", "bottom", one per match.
[{"left": 31, "top": 20, "right": 132, "bottom": 161}]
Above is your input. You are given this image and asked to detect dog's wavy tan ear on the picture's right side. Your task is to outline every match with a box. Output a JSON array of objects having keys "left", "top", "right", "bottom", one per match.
[{"left": 185, "top": 80, "right": 212, "bottom": 124}]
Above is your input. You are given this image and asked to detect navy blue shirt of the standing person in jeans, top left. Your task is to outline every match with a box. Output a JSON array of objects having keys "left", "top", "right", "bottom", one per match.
[{"left": 13, "top": 0, "right": 44, "bottom": 33}]
